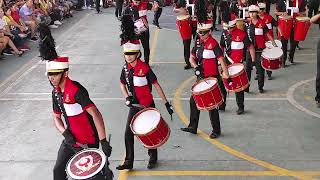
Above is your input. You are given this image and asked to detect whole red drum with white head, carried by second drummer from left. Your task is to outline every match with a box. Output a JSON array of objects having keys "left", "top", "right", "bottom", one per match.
[{"left": 130, "top": 108, "right": 170, "bottom": 149}]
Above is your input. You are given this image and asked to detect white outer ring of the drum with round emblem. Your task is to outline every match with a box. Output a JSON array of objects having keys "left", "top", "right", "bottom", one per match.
[{"left": 66, "top": 148, "right": 107, "bottom": 180}]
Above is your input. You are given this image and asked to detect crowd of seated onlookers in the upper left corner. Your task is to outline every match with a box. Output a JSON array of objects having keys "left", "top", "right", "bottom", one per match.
[{"left": 0, "top": 0, "right": 106, "bottom": 60}]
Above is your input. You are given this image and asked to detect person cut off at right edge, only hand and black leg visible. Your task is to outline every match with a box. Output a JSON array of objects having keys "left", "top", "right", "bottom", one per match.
[{"left": 310, "top": 13, "right": 320, "bottom": 108}]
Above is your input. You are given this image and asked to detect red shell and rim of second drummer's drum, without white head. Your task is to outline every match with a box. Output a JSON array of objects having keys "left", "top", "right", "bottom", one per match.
[{"left": 130, "top": 108, "right": 170, "bottom": 149}]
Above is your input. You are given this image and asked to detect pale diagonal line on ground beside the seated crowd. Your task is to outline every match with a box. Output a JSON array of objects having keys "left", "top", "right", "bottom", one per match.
[{"left": 0, "top": 13, "right": 92, "bottom": 97}]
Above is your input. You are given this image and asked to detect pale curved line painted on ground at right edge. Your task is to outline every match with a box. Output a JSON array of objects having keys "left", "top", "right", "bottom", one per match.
[{"left": 287, "top": 77, "right": 320, "bottom": 118}]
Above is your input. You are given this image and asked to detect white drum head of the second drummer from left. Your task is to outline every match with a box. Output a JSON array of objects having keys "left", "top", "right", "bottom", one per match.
[{"left": 131, "top": 108, "right": 161, "bottom": 134}]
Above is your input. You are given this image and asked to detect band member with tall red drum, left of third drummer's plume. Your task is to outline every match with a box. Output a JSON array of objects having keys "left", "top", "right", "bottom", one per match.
[{"left": 173, "top": 0, "right": 192, "bottom": 69}]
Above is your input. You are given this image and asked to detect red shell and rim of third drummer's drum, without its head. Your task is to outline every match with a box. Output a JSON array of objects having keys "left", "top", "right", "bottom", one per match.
[{"left": 191, "top": 77, "right": 223, "bottom": 110}]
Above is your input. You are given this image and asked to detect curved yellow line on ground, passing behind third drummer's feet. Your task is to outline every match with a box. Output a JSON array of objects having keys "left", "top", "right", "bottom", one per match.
[{"left": 173, "top": 77, "right": 312, "bottom": 179}]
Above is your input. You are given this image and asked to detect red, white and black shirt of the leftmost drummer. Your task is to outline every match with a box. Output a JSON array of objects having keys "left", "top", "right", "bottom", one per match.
[{"left": 52, "top": 78, "right": 99, "bottom": 144}]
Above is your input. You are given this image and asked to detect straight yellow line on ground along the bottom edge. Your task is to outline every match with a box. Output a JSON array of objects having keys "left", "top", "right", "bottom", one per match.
[{"left": 128, "top": 170, "right": 320, "bottom": 176}]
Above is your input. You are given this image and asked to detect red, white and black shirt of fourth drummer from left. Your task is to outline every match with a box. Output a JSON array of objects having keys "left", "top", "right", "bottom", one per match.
[{"left": 220, "top": 27, "right": 252, "bottom": 63}]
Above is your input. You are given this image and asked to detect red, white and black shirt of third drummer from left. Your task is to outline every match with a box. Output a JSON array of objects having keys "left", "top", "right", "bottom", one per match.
[{"left": 191, "top": 35, "right": 223, "bottom": 78}]
